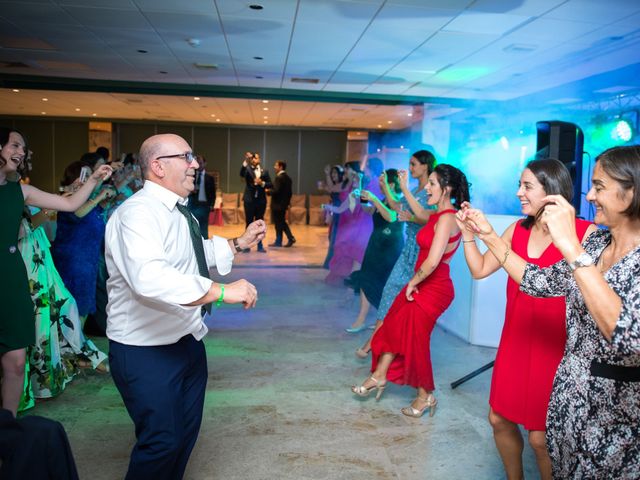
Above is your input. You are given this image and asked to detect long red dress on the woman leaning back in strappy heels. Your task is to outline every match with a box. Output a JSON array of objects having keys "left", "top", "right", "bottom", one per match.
[{"left": 371, "top": 210, "right": 461, "bottom": 391}]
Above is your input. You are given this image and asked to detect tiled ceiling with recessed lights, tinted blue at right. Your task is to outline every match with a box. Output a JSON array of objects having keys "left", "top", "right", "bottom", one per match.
[{"left": 0, "top": 0, "right": 640, "bottom": 129}]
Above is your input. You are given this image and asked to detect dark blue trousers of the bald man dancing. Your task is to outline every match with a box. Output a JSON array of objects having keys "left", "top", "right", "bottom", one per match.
[{"left": 109, "top": 335, "right": 207, "bottom": 480}]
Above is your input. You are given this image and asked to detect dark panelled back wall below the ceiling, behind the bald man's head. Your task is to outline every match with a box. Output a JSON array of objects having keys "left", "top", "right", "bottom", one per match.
[{"left": 0, "top": 117, "right": 347, "bottom": 193}]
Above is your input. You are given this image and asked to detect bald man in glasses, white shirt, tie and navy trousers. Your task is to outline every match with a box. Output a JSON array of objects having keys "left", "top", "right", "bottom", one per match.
[{"left": 105, "top": 134, "right": 266, "bottom": 480}]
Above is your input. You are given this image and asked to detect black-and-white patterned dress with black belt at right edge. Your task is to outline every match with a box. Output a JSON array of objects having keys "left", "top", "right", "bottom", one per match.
[{"left": 520, "top": 230, "right": 640, "bottom": 479}]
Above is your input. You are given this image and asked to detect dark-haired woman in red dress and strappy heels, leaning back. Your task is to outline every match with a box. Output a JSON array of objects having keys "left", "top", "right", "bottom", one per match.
[{"left": 351, "top": 164, "right": 469, "bottom": 417}]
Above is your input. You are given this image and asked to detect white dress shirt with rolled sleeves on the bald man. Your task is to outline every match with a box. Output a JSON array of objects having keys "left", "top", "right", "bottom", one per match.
[{"left": 105, "top": 181, "right": 234, "bottom": 346}]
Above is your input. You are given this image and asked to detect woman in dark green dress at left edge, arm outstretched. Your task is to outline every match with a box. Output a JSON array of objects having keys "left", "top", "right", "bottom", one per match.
[{"left": 0, "top": 127, "right": 112, "bottom": 415}]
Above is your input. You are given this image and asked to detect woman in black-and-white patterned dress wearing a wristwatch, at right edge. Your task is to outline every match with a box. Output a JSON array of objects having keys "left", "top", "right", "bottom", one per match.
[{"left": 459, "top": 145, "right": 640, "bottom": 479}]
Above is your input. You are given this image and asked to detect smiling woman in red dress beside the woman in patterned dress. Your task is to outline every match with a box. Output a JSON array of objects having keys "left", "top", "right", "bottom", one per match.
[{"left": 462, "top": 159, "right": 596, "bottom": 480}]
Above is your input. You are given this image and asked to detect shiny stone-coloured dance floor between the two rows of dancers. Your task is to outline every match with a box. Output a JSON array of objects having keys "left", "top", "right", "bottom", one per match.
[{"left": 29, "top": 226, "right": 537, "bottom": 480}]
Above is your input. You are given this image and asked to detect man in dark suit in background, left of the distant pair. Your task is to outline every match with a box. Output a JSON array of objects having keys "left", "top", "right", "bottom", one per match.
[{"left": 240, "top": 152, "right": 272, "bottom": 253}]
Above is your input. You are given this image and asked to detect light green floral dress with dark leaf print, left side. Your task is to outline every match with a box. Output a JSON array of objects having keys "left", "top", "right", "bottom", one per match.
[{"left": 18, "top": 212, "right": 107, "bottom": 410}]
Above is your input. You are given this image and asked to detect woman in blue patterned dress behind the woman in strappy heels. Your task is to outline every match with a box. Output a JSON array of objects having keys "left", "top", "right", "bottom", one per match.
[{"left": 356, "top": 150, "right": 436, "bottom": 358}]
